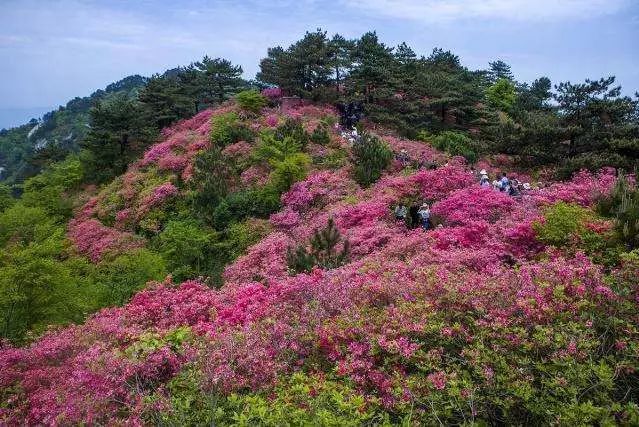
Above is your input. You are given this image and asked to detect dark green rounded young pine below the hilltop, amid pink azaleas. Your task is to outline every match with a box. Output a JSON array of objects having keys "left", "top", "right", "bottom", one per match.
[{"left": 352, "top": 134, "right": 393, "bottom": 187}]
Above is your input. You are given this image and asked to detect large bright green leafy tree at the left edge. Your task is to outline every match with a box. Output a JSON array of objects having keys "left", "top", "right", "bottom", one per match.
[{"left": 0, "top": 203, "right": 89, "bottom": 342}]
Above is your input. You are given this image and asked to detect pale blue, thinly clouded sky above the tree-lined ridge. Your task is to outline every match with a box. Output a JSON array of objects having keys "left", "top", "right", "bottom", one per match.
[{"left": 0, "top": 0, "right": 639, "bottom": 128}]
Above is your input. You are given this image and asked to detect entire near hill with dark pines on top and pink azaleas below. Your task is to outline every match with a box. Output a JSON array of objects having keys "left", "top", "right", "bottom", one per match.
[{"left": 0, "top": 30, "right": 639, "bottom": 426}]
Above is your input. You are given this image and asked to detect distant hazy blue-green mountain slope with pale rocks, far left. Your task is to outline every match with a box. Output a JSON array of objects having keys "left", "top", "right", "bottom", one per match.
[{"left": 0, "top": 75, "right": 148, "bottom": 182}]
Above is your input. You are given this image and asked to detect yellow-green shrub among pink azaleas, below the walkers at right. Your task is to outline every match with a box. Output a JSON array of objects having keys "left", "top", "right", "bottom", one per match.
[{"left": 534, "top": 202, "right": 592, "bottom": 247}]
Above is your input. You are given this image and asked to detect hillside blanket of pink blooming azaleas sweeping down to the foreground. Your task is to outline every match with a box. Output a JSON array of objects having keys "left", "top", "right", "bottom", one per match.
[{"left": 0, "top": 104, "right": 639, "bottom": 425}]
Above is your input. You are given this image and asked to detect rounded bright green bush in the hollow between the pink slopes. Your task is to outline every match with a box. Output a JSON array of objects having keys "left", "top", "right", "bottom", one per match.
[{"left": 153, "top": 220, "right": 216, "bottom": 281}]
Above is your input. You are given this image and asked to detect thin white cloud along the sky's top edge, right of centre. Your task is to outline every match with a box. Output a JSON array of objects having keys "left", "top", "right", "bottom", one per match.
[{"left": 342, "top": 0, "right": 629, "bottom": 23}]
